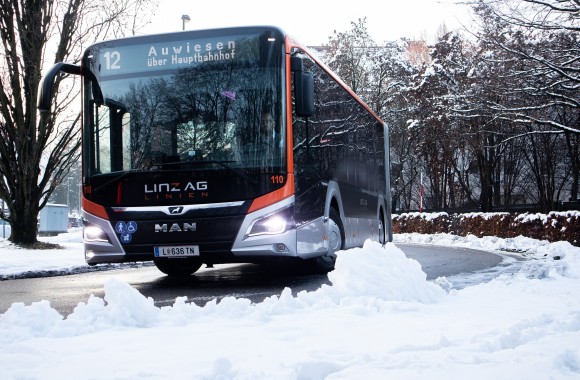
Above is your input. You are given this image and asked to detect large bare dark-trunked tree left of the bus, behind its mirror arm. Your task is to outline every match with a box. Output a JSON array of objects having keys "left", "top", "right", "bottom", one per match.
[{"left": 0, "top": 0, "right": 150, "bottom": 245}]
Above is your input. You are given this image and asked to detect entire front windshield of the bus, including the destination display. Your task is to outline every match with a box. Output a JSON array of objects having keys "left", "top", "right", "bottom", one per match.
[{"left": 83, "top": 33, "right": 286, "bottom": 176}]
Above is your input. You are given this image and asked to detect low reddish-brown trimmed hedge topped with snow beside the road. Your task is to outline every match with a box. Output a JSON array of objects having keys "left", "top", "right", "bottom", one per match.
[{"left": 393, "top": 211, "right": 580, "bottom": 246}]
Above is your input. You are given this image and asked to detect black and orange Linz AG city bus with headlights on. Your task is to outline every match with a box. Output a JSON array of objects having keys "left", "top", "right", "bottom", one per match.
[{"left": 38, "top": 26, "right": 392, "bottom": 276}]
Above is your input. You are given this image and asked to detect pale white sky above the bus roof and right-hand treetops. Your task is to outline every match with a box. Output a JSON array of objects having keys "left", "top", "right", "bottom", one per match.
[{"left": 143, "top": 0, "right": 469, "bottom": 46}]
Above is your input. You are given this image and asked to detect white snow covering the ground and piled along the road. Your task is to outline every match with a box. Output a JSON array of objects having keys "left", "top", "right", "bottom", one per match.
[{"left": 0, "top": 233, "right": 580, "bottom": 380}]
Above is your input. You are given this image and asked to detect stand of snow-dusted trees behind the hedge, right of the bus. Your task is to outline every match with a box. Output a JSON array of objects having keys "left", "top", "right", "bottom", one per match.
[{"left": 323, "top": 8, "right": 580, "bottom": 211}]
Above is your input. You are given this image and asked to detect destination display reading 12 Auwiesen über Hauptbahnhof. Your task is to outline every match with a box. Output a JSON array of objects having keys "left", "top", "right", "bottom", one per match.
[{"left": 98, "top": 35, "right": 259, "bottom": 80}]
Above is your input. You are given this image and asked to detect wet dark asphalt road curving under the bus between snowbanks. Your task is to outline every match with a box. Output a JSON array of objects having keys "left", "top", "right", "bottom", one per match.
[{"left": 0, "top": 243, "right": 502, "bottom": 316}]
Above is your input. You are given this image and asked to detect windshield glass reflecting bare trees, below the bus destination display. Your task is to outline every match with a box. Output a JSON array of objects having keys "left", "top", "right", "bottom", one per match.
[{"left": 88, "top": 35, "right": 285, "bottom": 173}]
